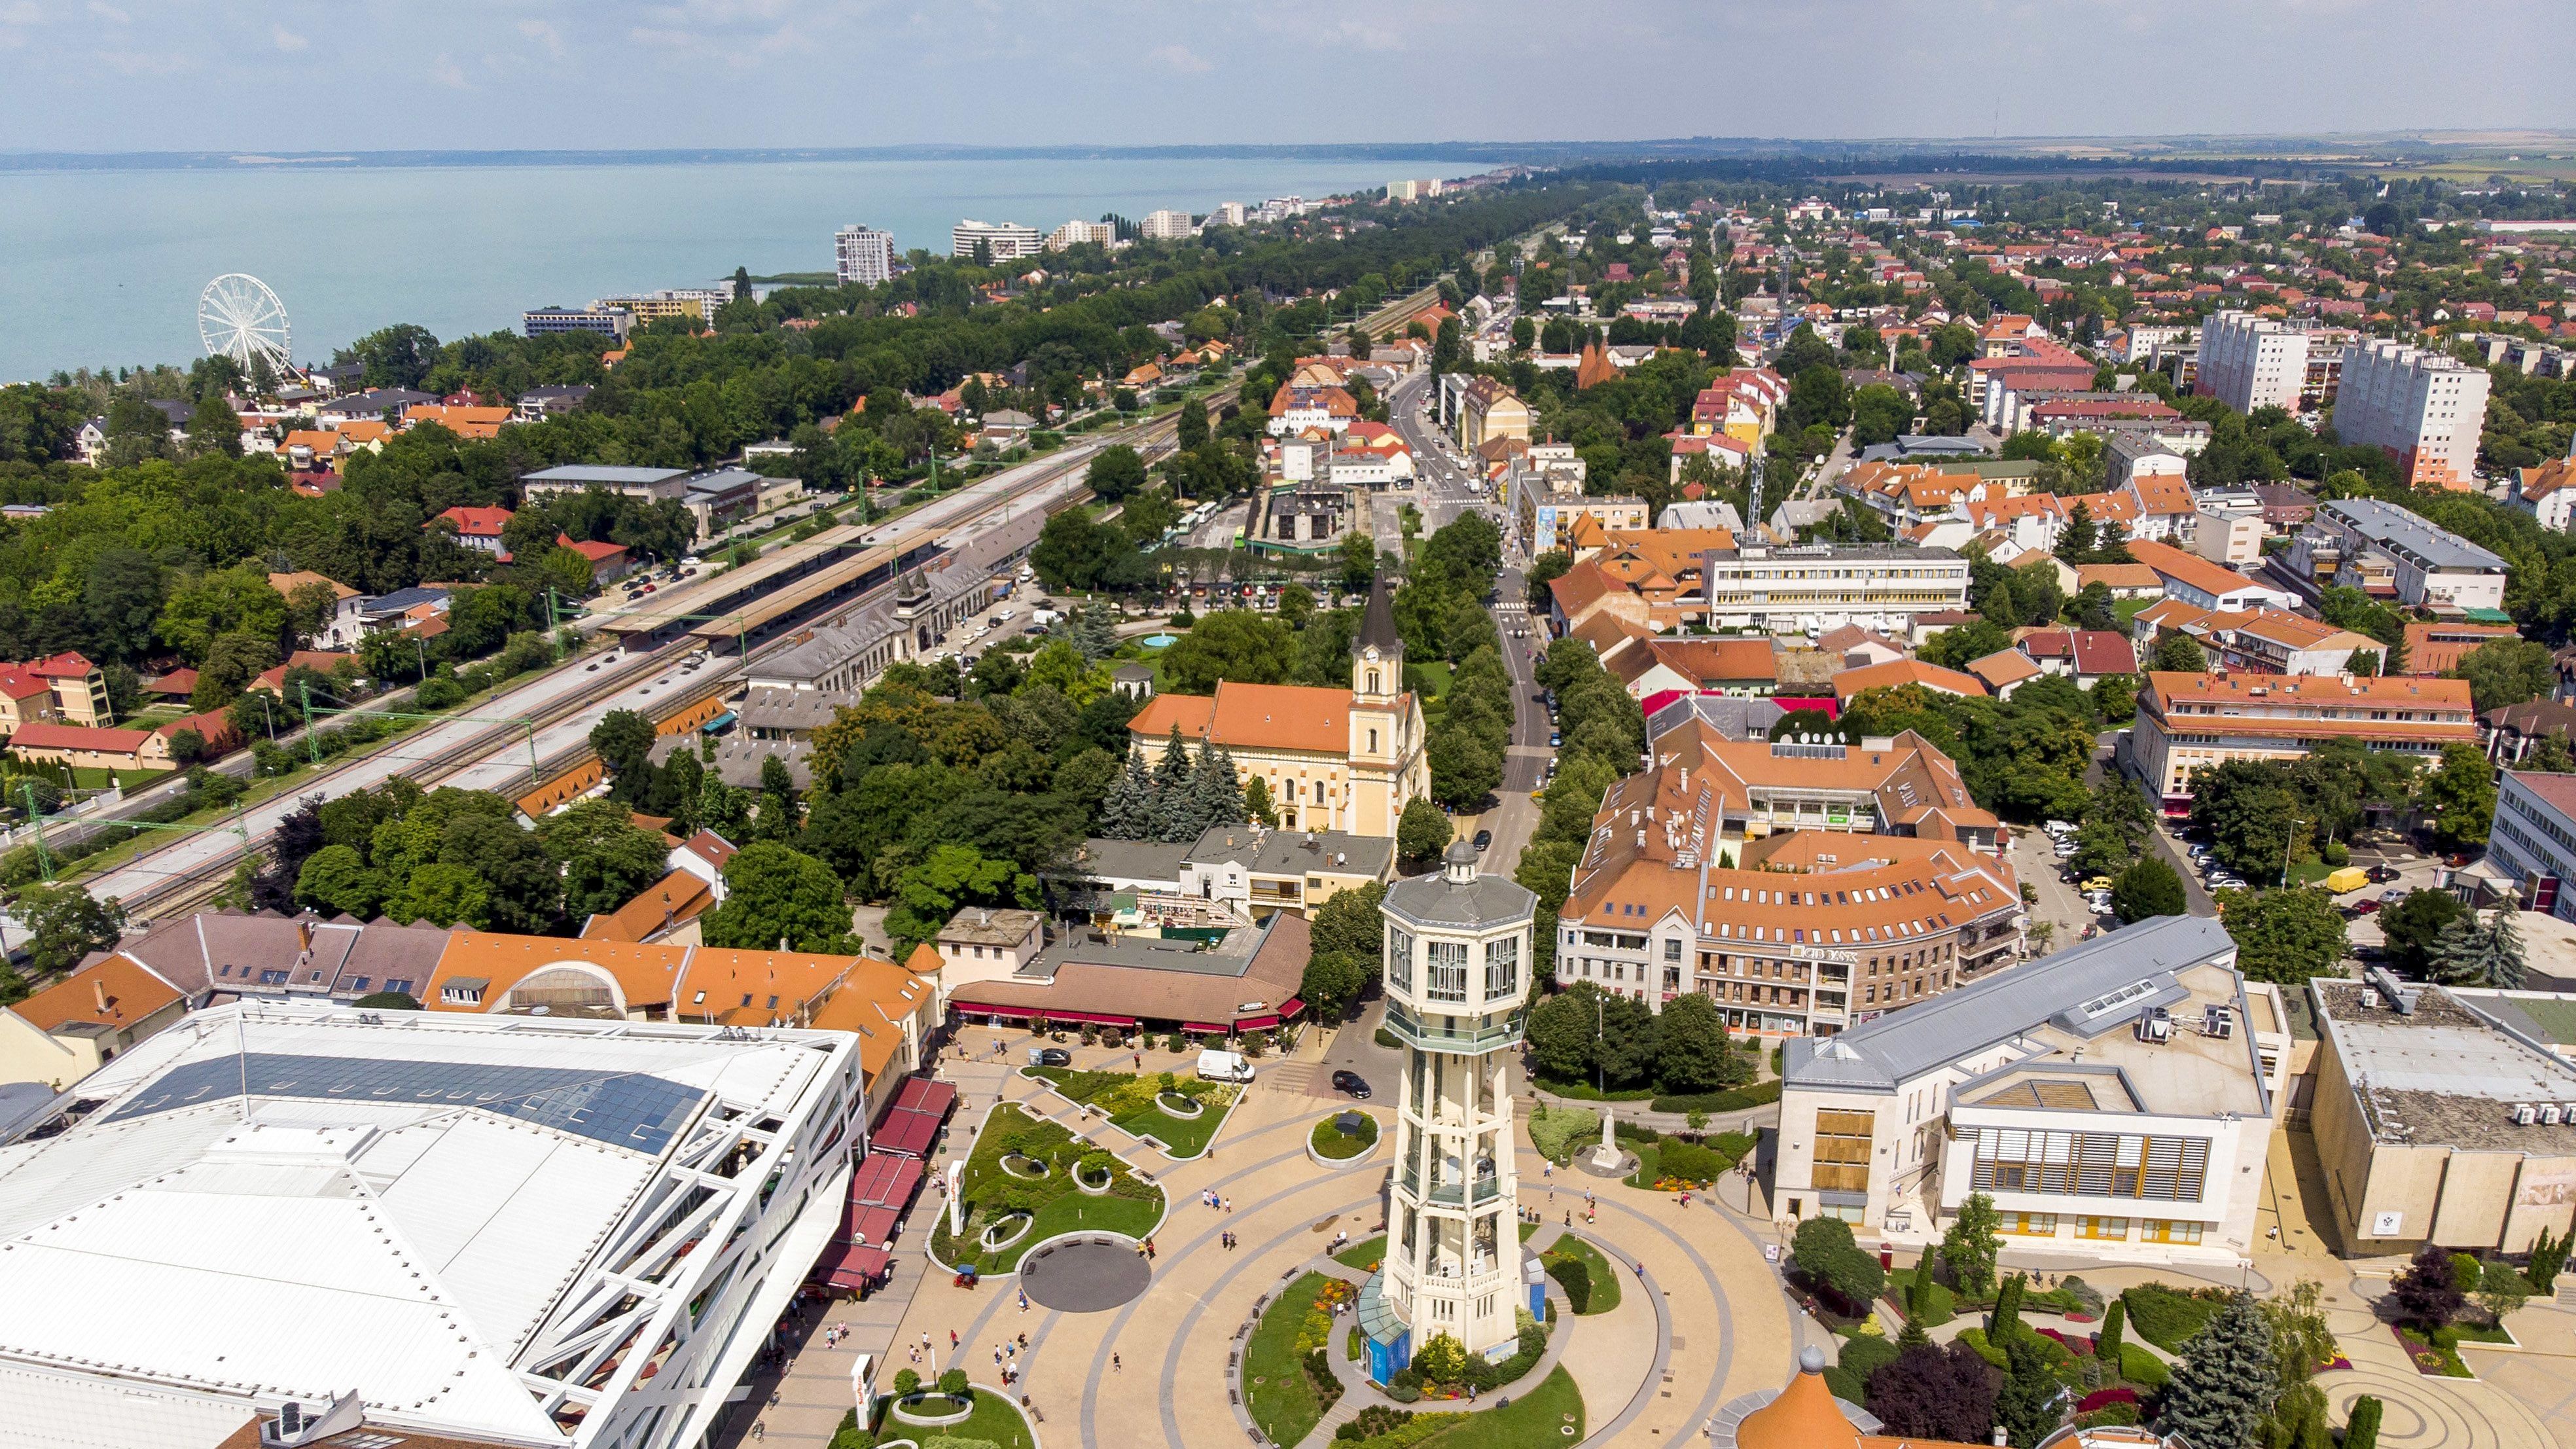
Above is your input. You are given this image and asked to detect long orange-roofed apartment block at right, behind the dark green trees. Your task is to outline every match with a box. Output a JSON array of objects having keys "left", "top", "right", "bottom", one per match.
[{"left": 2130, "top": 670, "right": 2478, "bottom": 815}]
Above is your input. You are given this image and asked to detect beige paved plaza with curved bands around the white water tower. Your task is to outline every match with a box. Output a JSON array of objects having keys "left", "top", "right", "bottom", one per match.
[{"left": 729, "top": 1026, "right": 2576, "bottom": 1449}]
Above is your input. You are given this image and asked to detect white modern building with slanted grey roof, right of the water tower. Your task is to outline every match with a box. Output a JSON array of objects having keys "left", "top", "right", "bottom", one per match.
[{"left": 1772, "top": 916, "right": 2290, "bottom": 1263}]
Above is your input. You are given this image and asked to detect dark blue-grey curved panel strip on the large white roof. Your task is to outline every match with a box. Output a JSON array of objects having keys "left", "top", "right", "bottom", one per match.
[{"left": 108, "top": 1052, "right": 706, "bottom": 1155}]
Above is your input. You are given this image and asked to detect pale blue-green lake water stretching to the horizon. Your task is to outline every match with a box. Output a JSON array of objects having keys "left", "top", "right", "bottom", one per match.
[{"left": 0, "top": 157, "right": 1456, "bottom": 382}]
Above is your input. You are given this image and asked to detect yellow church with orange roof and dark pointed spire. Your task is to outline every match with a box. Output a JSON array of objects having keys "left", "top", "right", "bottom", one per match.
[{"left": 1128, "top": 577, "right": 1432, "bottom": 835}]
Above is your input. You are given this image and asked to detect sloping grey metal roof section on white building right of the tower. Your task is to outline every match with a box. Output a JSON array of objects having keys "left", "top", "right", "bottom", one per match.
[{"left": 1780, "top": 916, "right": 2236, "bottom": 1090}]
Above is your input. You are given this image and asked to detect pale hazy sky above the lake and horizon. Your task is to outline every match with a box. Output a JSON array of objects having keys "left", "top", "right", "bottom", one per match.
[{"left": 0, "top": 0, "right": 2576, "bottom": 152}]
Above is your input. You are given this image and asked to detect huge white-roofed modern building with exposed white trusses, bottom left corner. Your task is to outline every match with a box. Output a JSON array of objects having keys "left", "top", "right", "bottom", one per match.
[{"left": 0, "top": 1003, "right": 865, "bottom": 1449}]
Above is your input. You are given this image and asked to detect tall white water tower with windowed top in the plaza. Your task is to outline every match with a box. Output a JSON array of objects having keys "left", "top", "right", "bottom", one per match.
[{"left": 1360, "top": 840, "right": 1538, "bottom": 1380}]
